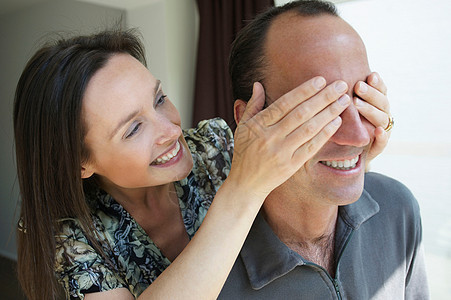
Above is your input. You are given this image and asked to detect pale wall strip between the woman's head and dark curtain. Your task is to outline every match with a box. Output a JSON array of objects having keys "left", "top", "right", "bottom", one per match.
[{"left": 127, "top": 0, "right": 199, "bottom": 128}]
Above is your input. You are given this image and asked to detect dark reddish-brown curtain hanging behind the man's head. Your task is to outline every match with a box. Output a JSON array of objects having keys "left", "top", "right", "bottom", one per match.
[{"left": 193, "top": 0, "right": 274, "bottom": 128}]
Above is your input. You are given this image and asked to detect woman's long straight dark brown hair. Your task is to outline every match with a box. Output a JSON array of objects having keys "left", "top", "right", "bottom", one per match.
[{"left": 14, "top": 30, "right": 145, "bottom": 300}]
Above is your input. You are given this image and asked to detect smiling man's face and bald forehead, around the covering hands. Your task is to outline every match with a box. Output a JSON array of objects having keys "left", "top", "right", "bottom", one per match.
[{"left": 263, "top": 12, "right": 374, "bottom": 205}]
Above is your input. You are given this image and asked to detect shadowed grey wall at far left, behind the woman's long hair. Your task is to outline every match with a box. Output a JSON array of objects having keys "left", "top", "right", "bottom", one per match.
[{"left": 0, "top": 0, "right": 123, "bottom": 259}]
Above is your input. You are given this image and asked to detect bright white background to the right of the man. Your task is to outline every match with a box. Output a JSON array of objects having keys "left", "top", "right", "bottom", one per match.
[{"left": 338, "top": 0, "right": 451, "bottom": 299}]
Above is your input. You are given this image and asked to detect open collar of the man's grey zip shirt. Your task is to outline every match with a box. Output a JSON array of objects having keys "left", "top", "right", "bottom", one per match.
[{"left": 240, "top": 186, "right": 379, "bottom": 290}]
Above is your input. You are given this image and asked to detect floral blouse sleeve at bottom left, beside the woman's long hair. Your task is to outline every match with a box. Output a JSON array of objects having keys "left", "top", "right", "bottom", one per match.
[{"left": 55, "top": 219, "right": 128, "bottom": 299}]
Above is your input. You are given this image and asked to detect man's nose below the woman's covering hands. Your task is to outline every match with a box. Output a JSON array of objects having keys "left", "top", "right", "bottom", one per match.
[{"left": 330, "top": 104, "right": 371, "bottom": 147}]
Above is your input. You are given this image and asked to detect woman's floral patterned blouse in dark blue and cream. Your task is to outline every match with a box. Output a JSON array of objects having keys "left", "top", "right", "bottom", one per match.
[{"left": 55, "top": 119, "right": 233, "bottom": 299}]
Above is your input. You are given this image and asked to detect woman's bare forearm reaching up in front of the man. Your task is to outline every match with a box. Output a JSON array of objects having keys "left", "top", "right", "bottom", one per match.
[{"left": 138, "top": 180, "right": 264, "bottom": 299}]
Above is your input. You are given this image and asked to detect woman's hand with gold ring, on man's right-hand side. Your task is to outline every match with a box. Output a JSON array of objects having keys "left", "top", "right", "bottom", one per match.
[{"left": 354, "top": 72, "right": 390, "bottom": 169}]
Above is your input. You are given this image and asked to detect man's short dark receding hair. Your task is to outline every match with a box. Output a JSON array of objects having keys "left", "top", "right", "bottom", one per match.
[{"left": 229, "top": 0, "right": 338, "bottom": 101}]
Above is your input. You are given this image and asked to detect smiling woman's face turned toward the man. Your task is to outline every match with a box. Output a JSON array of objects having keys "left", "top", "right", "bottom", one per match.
[{"left": 82, "top": 54, "right": 193, "bottom": 188}]
